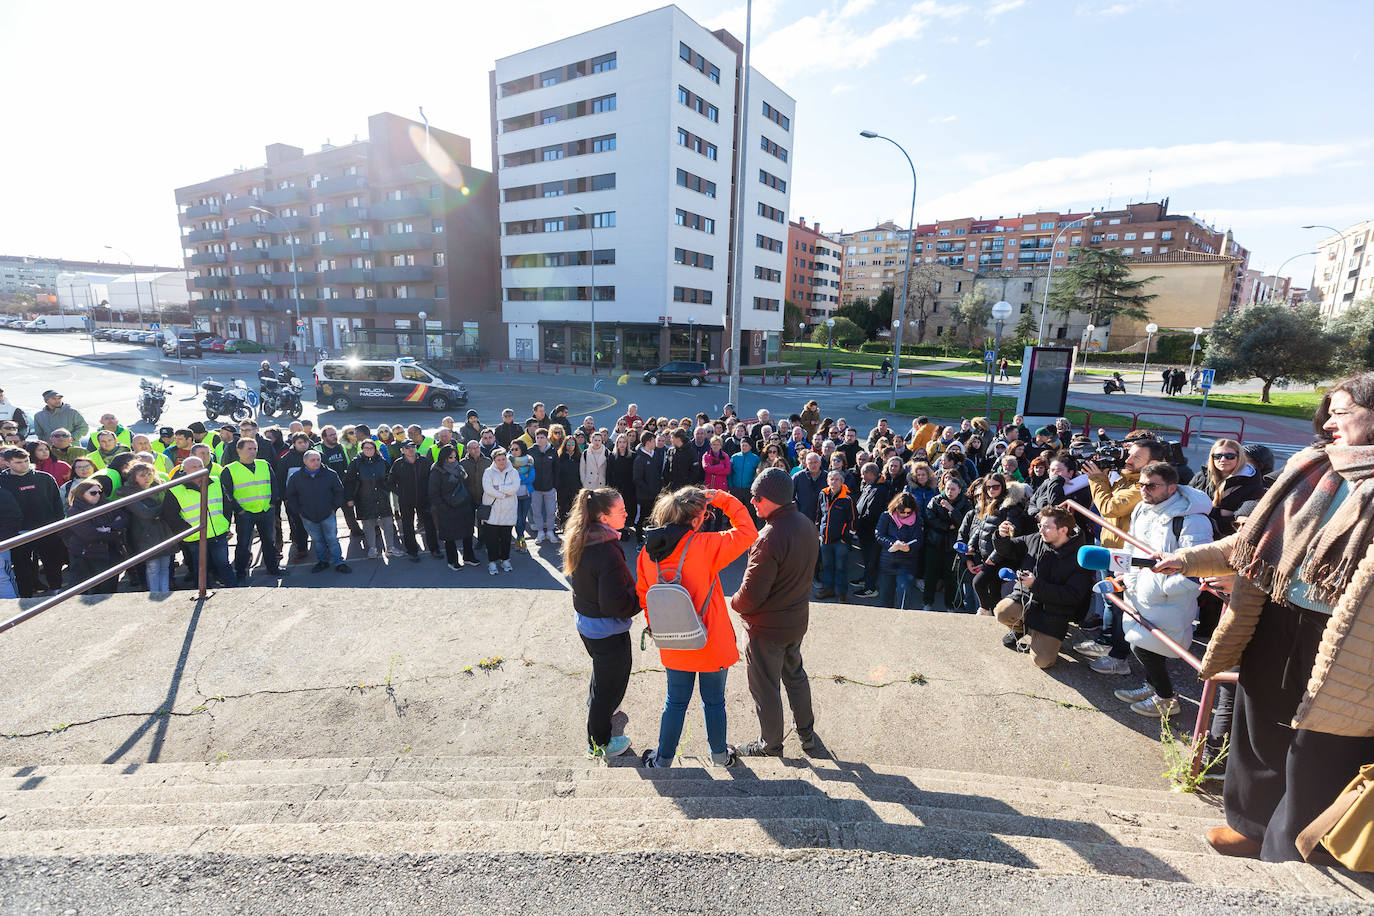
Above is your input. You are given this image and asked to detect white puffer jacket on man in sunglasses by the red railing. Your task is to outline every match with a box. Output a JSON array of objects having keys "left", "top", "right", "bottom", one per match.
[{"left": 1124, "top": 486, "right": 1212, "bottom": 658}]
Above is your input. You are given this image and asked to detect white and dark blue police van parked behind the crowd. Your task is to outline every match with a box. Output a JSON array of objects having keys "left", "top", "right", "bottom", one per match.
[{"left": 315, "top": 357, "right": 467, "bottom": 411}]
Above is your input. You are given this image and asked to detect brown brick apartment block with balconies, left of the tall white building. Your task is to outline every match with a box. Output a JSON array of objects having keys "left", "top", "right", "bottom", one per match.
[{"left": 176, "top": 113, "right": 504, "bottom": 356}]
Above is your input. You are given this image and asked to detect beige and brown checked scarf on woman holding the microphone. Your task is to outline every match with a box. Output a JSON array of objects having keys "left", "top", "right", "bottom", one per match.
[{"left": 1231, "top": 445, "right": 1374, "bottom": 607}]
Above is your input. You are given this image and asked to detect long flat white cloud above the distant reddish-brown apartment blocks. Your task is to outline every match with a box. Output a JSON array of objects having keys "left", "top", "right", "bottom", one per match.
[{"left": 922, "top": 140, "right": 1370, "bottom": 218}]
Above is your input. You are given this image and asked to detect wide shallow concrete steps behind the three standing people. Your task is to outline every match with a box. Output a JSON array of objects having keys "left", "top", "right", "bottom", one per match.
[{"left": 0, "top": 757, "right": 1374, "bottom": 905}]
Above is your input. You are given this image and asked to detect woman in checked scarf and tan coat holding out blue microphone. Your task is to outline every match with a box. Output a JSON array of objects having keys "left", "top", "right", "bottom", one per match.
[{"left": 1153, "top": 372, "right": 1374, "bottom": 862}]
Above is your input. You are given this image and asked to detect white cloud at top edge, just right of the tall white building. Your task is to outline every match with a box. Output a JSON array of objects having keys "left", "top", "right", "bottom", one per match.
[{"left": 753, "top": 0, "right": 969, "bottom": 81}]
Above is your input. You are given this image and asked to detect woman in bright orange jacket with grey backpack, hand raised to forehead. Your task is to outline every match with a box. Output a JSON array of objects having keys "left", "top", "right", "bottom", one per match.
[{"left": 635, "top": 486, "right": 758, "bottom": 766}]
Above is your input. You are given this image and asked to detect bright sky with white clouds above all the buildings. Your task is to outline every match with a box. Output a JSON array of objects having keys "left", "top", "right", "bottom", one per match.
[{"left": 0, "top": 0, "right": 1374, "bottom": 286}]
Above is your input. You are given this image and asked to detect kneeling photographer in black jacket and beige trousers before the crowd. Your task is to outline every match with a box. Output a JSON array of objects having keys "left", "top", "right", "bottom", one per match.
[{"left": 988, "top": 505, "right": 1092, "bottom": 667}]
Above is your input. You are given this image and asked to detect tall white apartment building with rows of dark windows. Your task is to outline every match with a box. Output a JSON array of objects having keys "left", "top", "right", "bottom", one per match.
[{"left": 491, "top": 7, "right": 796, "bottom": 368}]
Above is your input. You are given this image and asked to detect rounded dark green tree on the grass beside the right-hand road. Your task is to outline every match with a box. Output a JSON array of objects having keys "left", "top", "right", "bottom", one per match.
[{"left": 1205, "top": 301, "right": 1341, "bottom": 404}]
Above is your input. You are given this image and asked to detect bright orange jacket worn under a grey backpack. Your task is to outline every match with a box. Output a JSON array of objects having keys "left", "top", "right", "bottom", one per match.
[{"left": 635, "top": 490, "right": 758, "bottom": 672}]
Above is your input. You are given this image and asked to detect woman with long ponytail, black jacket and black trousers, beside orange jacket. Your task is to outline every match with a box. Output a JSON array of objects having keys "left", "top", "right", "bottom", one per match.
[{"left": 563, "top": 486, "right": 640, "bottom": 757}]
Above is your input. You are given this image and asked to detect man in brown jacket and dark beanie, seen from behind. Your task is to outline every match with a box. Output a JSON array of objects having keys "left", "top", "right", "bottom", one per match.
[{"left": 730, "top": 468, "right": 820, "bottom": 757}]
